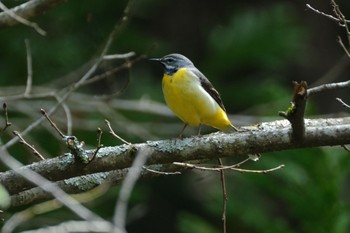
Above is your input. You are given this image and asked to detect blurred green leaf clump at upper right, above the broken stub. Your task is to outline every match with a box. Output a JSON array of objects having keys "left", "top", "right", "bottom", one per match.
[{"left": 207, "top": 3, "right": 305, "bottom": 75}]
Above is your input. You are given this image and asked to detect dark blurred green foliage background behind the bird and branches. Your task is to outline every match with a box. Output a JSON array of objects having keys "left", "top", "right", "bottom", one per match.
[{"left": 0, "top": 0, "right": 350, "bottom": 233}]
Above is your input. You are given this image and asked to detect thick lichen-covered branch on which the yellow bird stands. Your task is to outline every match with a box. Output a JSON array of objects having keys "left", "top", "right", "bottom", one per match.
[{"left": 0, "top": 117, "right": 350, "bottom": 204}]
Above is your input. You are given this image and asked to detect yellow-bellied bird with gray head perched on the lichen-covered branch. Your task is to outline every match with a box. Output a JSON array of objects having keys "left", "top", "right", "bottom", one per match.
[{"left": 150, "top": 53, "right": 238, "bottom": 137}]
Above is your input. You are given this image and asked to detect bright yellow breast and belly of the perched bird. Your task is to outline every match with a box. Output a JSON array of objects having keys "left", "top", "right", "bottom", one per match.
[{"left": 162, "top": 69, "right": 232, "bottom": 131}]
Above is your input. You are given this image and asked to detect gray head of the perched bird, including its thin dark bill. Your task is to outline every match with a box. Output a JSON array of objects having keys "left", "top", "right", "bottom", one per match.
[{"left": 150, "top": 53, "right": 193, "bottom": 75}]
